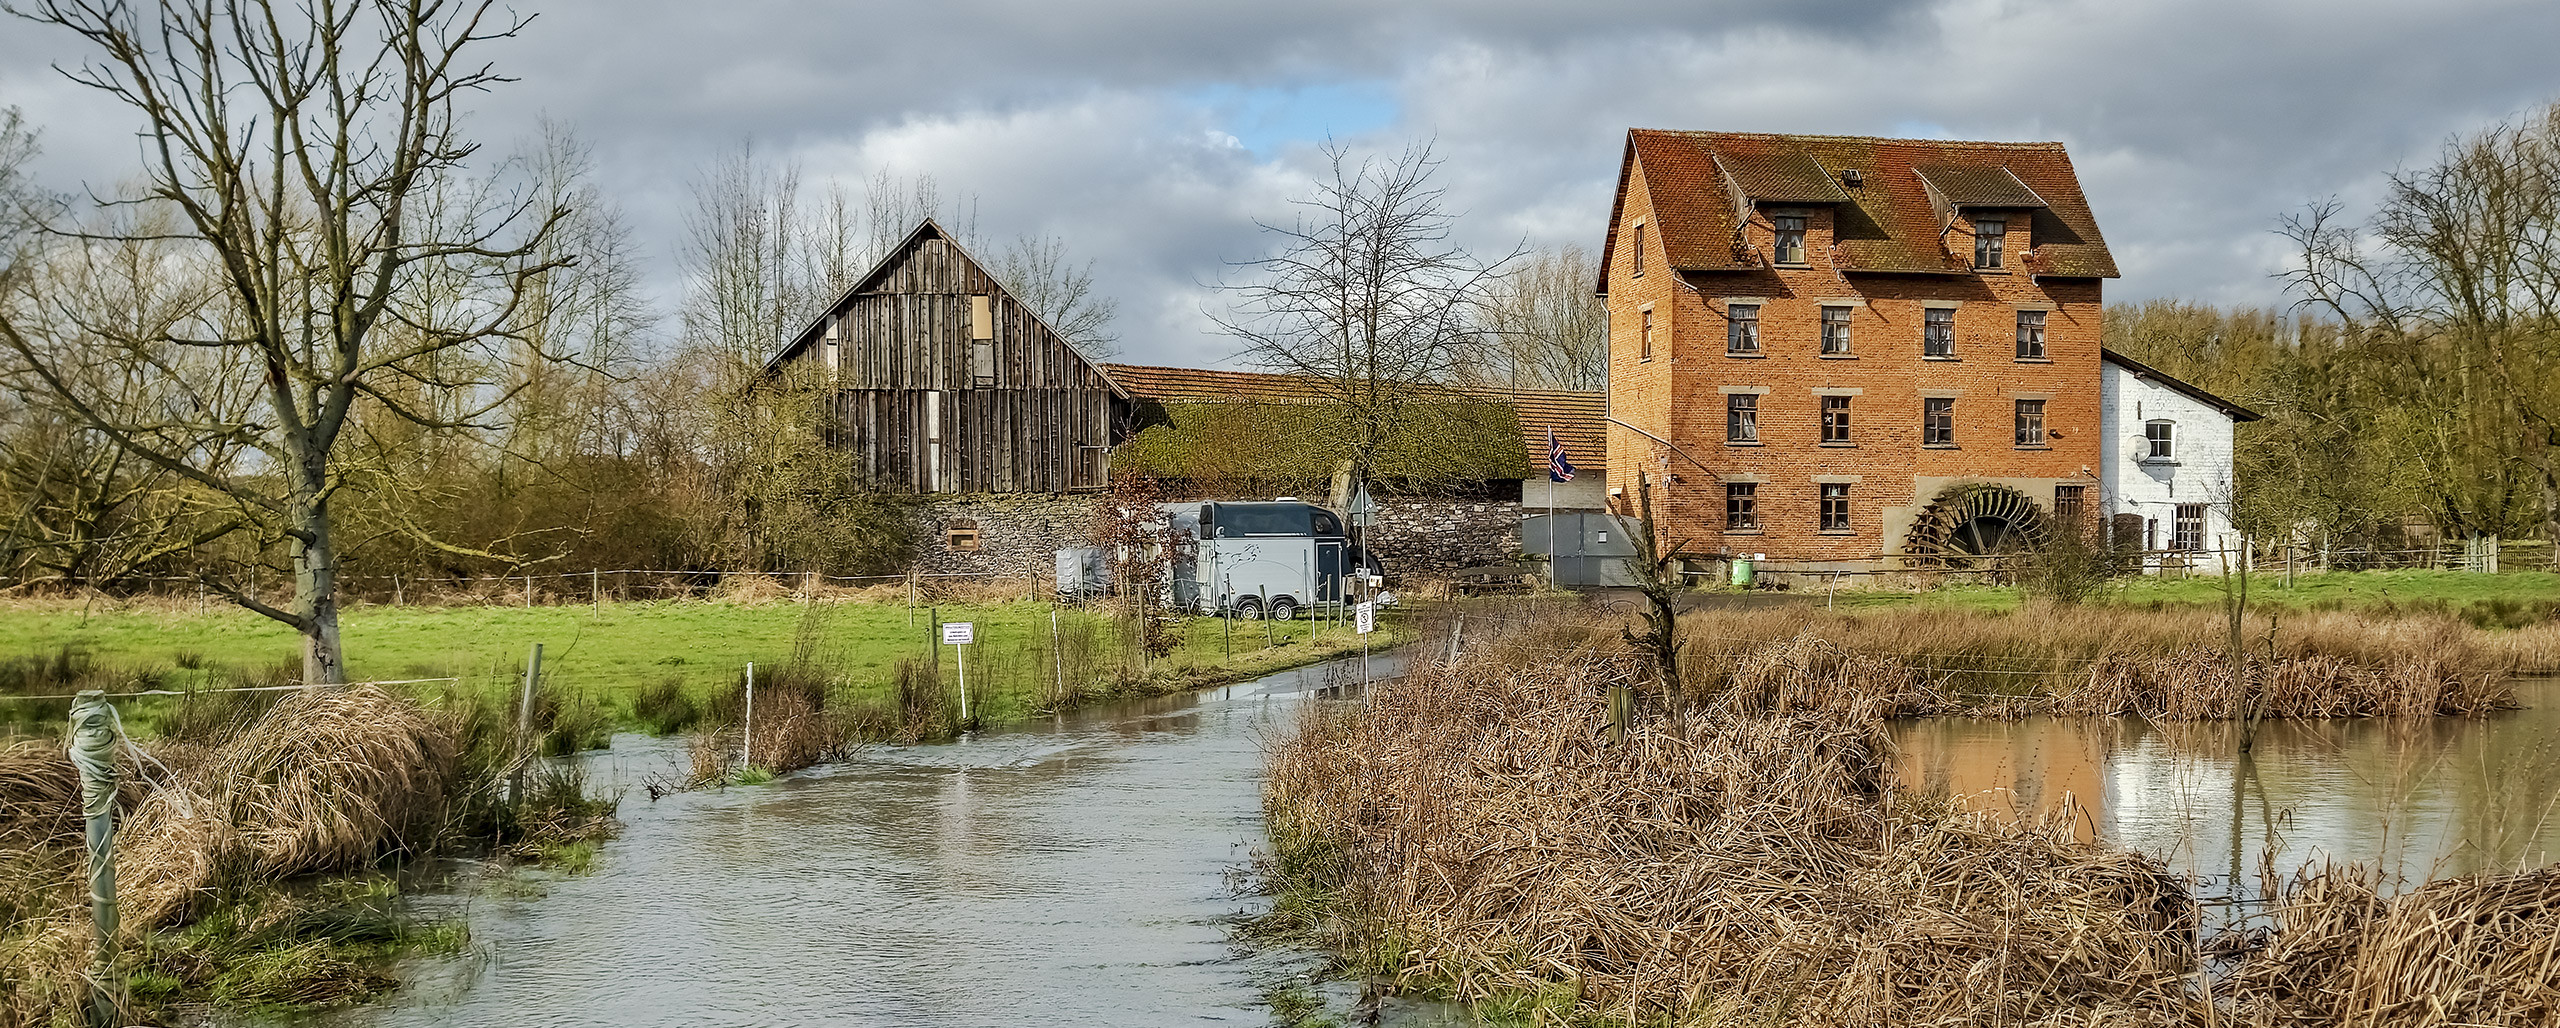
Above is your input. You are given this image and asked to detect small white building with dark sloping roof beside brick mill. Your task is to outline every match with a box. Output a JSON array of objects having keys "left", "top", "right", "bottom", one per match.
[{"left": 2099, "top": 350, "right": 2258, "bottom": 573}]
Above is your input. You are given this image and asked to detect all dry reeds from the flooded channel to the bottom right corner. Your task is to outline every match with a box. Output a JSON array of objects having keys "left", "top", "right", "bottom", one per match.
[{"left": 1262, "top": 632, "right": 2560, "bottom": 1025}]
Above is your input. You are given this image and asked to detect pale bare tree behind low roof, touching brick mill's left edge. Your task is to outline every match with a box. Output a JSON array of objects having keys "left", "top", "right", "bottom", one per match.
[{"left": 1464, "top": 245, "right": 1608, "bottom": 389}]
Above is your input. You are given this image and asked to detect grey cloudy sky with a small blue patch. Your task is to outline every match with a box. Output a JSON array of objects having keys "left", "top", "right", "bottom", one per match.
[{"left": 0, "top": 0, "right": 2560, "bottom": 366}]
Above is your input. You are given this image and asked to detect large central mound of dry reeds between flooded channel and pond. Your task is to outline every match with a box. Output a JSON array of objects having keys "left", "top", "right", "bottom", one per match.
[{"left": 1267, "top": 657, "right": 2199, "bottom": 1025}]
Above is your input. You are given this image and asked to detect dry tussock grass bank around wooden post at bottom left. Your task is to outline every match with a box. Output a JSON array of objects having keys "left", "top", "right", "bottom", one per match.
[{"left": 0, "top": 688, "right": 614, "bottom": 1028}]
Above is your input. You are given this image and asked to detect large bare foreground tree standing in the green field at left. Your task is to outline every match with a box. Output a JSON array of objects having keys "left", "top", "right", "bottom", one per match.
[{"left": 0, "top": 0, "right": 561, "bottom": 683}]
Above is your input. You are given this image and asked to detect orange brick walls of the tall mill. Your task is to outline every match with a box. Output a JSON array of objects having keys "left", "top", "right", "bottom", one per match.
[{"left": 1608, "top": 166, "right": 2102, "bottom": 563}]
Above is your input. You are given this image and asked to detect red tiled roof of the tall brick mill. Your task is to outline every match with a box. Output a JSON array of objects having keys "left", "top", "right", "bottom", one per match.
[{"left": 1600, "top": 128, "right": 2117, "bottom": 279}]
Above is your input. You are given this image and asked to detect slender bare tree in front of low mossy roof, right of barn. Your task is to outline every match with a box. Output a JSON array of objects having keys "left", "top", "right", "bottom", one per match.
[{"left": 1211, "top": 143, "right": 1523, "bottom": 483}]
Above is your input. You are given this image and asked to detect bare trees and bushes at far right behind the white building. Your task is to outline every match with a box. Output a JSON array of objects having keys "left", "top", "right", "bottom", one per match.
[{"left": 2104, "top": 105, "right": 2560, "bottom": 550}]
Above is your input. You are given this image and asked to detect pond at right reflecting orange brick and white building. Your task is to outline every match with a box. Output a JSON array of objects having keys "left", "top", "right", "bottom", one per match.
[{"left": 1894, "top": 680, "right": 2560, "bottom": 890}]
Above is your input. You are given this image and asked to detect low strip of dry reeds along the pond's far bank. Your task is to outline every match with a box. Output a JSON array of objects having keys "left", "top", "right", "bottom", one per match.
[{"left": 1682, "top": 606, "right": 2514, "bottom": 721}]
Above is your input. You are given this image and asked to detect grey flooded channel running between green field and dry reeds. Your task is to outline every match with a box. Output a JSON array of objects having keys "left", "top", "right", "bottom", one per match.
[{"left": 244, "top": 657, "right": 1446, "bottom": 1028}]
